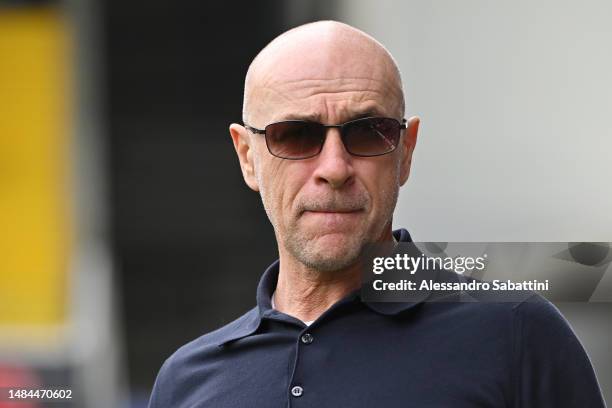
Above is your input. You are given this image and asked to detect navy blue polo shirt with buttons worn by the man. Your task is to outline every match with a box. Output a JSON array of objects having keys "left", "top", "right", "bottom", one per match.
[{"left": 149, "top": 230, "right": 605, "bottom": 408}]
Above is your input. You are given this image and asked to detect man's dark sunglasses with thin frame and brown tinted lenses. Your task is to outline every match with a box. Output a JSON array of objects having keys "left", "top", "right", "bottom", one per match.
[{"left": 244, "top": 117, "right": 406, "bottom": 160}]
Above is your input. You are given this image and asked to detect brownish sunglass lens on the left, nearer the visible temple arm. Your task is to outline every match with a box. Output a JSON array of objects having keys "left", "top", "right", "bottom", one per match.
[{"left": 266, "top": 121, "right": 325, "bottom": 159}]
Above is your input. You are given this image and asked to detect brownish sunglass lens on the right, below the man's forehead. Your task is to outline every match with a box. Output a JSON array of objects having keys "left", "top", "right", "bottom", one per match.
[{"left": 344, "top": 118, "right": 400, "bottom": 156}]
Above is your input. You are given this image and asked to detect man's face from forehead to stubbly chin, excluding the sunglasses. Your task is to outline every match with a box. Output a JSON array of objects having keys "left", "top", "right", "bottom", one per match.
[{"left": 230, "top": 30, "right": 416, "bottom": 271}]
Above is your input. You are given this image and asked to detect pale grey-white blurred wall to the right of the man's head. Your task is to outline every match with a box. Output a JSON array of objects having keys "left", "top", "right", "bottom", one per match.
[{"left": 339, "top": 0, "right": 612, "bottom": 241}]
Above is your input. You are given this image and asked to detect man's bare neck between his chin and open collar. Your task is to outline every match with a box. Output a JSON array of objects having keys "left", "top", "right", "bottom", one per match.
[{"left": 274, "top": 228, "right": 395, "bottom": 321}]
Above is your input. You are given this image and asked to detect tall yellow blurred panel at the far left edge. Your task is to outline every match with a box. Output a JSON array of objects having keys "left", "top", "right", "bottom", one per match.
[{"left": 0, "top": 7, "right": 72, "bottom": 328}]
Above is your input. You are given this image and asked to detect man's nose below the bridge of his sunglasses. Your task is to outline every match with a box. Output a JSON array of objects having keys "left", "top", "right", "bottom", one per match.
[{"left": 314, "top": 128, "right": 355, "bottom": 189}]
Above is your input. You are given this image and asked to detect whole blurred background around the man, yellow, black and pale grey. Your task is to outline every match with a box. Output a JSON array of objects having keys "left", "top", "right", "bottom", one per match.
[{"left": 0, "top": 0, "right": 612, "bottom": 408}]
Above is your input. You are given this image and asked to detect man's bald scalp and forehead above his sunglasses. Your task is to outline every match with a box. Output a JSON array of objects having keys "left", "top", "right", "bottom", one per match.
[{"left": 243, "top": 21, "right": 404, "bottom": 126}]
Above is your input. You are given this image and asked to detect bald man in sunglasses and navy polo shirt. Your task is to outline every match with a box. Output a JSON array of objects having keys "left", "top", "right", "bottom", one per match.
[{"left": 150, "top": 22, "right": 603, "bottom": 408}]
